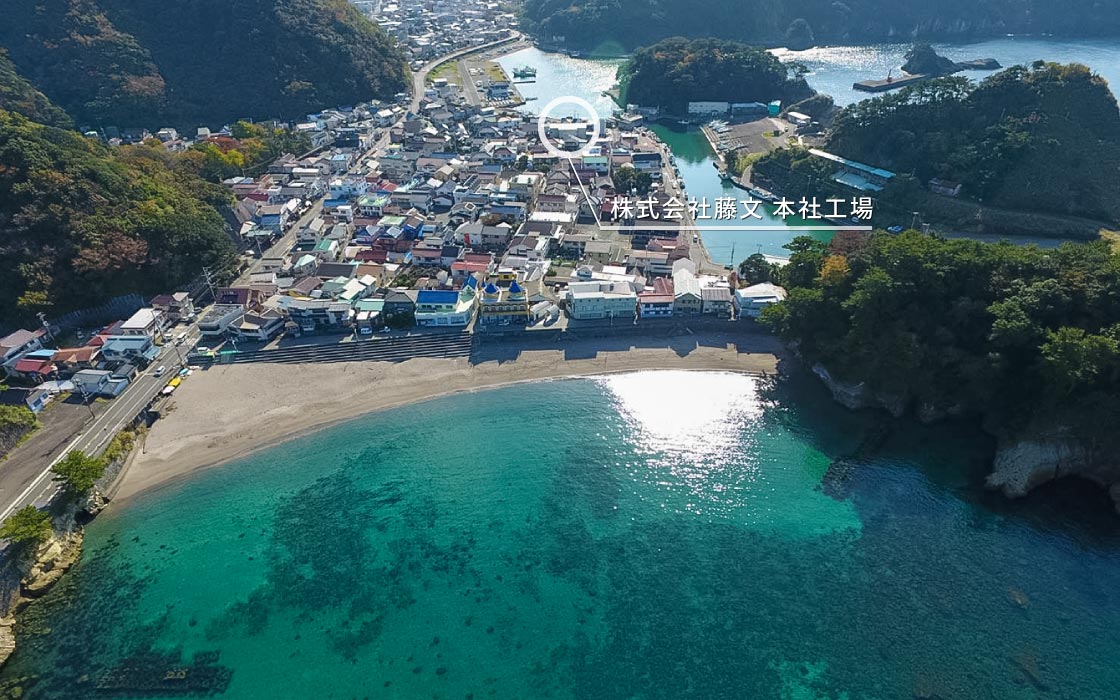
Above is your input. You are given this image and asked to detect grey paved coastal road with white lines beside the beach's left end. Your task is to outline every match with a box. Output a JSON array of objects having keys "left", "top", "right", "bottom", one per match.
[{"left": 0, "top": 325, "right": 200, "bottom": 521}]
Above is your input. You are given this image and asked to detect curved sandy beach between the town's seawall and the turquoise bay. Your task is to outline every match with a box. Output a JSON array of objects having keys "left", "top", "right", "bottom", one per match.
[{"left": 113, "top": 333, "right": 782, "bottom": 502}]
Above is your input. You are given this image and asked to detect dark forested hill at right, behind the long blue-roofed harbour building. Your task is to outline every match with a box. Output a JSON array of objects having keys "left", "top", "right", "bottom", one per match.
[{"left": 754, "top": 63, "right": 1120, "bottom": 228}]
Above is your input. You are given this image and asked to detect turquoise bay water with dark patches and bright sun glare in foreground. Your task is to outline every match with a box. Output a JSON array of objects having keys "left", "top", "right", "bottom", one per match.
[{"left": 0, "top": 372, "right": 1120, "bottom": 700}]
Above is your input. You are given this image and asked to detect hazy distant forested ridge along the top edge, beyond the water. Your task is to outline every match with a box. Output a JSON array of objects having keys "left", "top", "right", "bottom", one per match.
[{"left": 522, "top": 0, "right": 1120, "bottom": 50}]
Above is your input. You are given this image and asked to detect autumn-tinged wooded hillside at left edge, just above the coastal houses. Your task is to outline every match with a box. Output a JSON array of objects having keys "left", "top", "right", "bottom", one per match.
[{"left": 0, "top": 111, "right": 233, "bottom": 323}]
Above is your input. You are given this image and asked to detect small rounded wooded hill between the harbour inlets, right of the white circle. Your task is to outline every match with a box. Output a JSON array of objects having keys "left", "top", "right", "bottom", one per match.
[{"left": 618, "top": 37, "right": 813, "bottom": 114}]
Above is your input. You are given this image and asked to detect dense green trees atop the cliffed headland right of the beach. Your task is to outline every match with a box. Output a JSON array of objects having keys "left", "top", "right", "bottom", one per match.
[{"left": 761, "top": 231, "right": 1120, "bottom": 439}]
